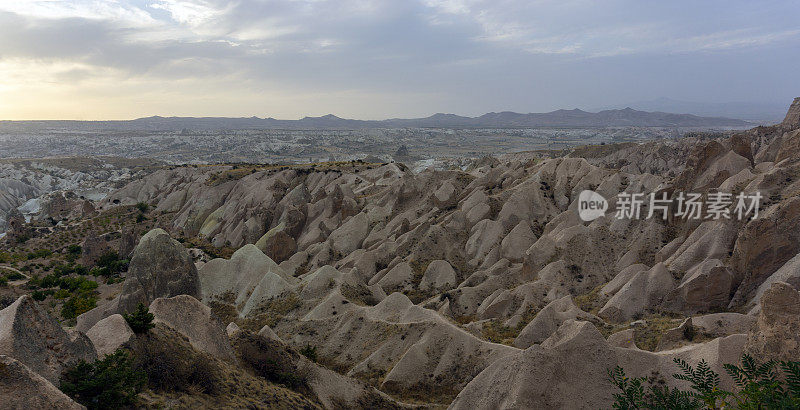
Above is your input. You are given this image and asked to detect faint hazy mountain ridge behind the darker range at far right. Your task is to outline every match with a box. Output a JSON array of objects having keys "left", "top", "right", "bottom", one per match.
[{"left": 597, "top": 97, "right": 791, "bottom": 123}]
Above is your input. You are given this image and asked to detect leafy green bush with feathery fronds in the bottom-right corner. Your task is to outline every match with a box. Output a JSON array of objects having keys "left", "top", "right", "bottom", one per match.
[{"left": 608, "top": 354, "right": 800, "bottom": 410}]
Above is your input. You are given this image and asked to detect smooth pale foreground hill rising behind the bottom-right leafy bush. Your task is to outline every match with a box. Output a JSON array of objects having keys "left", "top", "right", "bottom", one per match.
[{"left": 450, "top": 320, "right": 747, "bottom": 409}]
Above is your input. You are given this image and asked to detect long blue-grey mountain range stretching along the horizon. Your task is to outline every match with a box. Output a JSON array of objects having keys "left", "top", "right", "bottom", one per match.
[{"left": 0, "top": 108, "right": 753, "bottom": 131}]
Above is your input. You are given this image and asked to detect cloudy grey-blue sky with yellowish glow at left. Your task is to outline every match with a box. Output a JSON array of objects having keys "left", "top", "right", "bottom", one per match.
[{"left": 0, "top": 0, "right": 800, "bottom": 120}]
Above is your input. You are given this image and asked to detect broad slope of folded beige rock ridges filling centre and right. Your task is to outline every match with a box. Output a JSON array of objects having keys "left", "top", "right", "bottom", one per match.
[{"left": 48, "top": 98, "right": 800, "bottom": 407}]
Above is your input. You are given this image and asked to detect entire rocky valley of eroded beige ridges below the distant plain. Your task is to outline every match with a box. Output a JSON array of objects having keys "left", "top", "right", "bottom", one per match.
[{"left": 0, "top": 99, "right": 800, "bottom": 409}]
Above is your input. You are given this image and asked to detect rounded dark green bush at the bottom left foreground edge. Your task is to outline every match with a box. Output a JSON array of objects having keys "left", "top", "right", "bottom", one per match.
[{"left": 61, "top": 350, "right": 146, "bottom": 409}]
